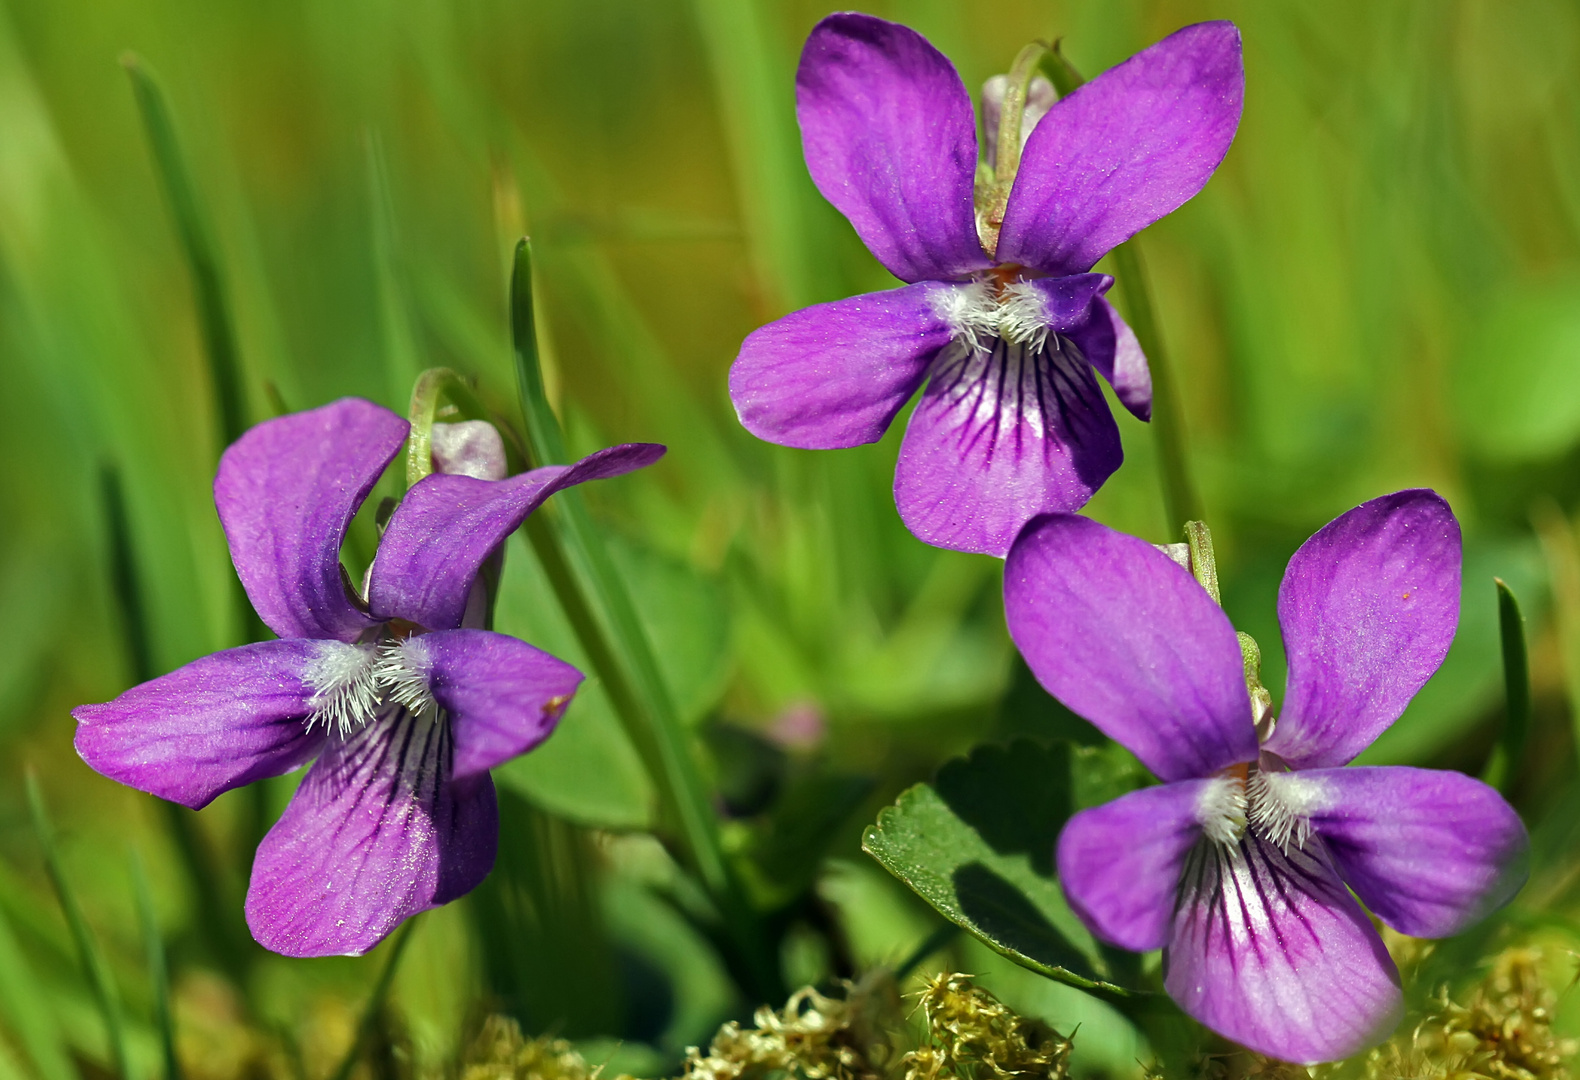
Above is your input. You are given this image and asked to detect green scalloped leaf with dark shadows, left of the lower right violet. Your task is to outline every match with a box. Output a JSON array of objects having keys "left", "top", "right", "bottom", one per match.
[{"left": 861, "top": 741, "right": 1134, "bottom": 1001}]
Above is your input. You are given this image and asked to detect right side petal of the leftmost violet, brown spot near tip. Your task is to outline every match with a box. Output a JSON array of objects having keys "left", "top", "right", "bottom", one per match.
[{"left": 406, "top": 630, "right": 583, "bottom": 778}]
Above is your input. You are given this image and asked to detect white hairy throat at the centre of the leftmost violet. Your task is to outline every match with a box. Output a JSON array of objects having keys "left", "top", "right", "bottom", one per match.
[{"left": 303, "top": 636, "right": 439, "bottom": 739}]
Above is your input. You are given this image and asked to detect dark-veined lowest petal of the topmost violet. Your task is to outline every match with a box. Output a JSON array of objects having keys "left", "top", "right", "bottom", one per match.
[{"left": 894, "top": 326, "right": 1125, "bottom": 556}]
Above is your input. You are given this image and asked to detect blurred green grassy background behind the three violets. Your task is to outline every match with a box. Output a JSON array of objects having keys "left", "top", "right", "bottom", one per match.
[{"left": 0, "top": 0, "right": 1580, "bottom": 1080}]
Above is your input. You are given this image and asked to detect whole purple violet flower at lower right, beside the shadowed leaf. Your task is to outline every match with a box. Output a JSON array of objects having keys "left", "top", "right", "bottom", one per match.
[{"left": 1005, "top": 491, "right": 1528, "bottom": 1064}]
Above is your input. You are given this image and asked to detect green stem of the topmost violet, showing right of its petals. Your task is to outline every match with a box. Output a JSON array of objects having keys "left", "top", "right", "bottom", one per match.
[{"left": 1042, "top": 43, "right": 1204, "bottom": 532}]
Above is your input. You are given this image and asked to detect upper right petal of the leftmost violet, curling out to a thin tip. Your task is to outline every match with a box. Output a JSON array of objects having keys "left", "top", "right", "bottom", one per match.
[{"left": 368, "top": 442, "right": 664, "bottom": 630}]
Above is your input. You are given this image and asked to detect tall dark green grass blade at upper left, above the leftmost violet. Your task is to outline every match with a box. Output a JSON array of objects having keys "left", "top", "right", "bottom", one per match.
[{"left": 122, "top": 54, "right": 246, "bottom": 445}]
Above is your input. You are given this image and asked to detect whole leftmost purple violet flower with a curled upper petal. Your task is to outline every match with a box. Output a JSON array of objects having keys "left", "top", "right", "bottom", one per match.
[{"left": 73, "top": 398, "right": 664, "bottom": 957}]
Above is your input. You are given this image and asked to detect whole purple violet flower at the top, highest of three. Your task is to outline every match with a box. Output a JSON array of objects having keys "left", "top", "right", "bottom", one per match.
[{"left": 730, "top": 13, "right": 1245, "bottom": 556}]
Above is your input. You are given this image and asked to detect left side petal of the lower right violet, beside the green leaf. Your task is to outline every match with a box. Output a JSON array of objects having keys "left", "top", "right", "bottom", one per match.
[{"left": 1059, "top": 780, "right": 1221, "bottom": 952}]
